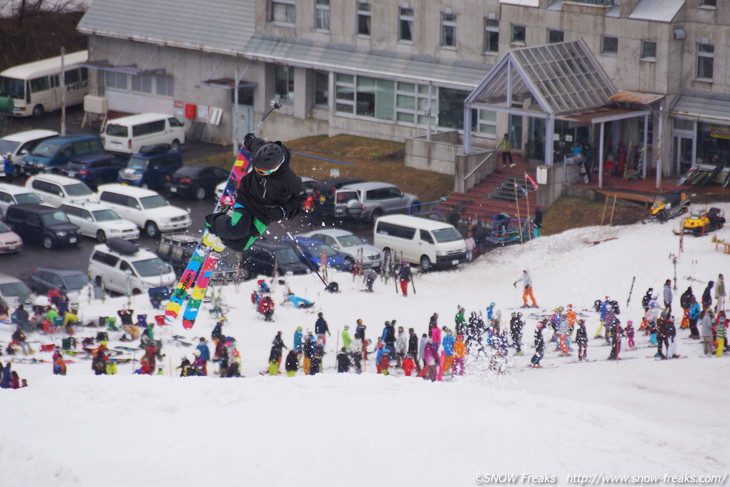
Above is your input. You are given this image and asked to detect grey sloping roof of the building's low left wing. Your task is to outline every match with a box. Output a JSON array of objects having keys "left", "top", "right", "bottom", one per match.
[{"left": 77, "top": 0, "right": 256, "bottom": 54}]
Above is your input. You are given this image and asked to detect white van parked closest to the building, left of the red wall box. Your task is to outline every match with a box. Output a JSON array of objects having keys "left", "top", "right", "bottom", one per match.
[{"left": 101, "top": 113, "right": 185, "bottom": 154}]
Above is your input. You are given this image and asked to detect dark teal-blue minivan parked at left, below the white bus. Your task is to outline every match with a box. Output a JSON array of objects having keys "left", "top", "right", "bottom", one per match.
[{"left": 22, "top": 134, "right": 104, "bottom": 175}]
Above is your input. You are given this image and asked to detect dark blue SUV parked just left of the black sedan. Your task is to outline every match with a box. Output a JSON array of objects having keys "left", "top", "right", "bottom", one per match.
[{"left": 117, "top": 144, "right": 182, "bottom": 191}]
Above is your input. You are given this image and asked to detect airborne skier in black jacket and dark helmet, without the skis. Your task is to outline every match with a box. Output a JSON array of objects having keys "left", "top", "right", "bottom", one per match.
[{"left": 205, "top": 134, "right": 312, "bottom": 252}]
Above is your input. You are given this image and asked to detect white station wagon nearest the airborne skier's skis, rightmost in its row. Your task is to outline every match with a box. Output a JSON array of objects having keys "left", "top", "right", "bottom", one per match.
[{"left": 99, "top": 184, "right": 192, "bottom": 237}]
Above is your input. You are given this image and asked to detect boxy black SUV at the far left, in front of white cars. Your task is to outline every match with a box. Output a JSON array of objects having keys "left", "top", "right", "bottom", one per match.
[{"left": 5, "top": 203, "right": 81, "bottom": 249}]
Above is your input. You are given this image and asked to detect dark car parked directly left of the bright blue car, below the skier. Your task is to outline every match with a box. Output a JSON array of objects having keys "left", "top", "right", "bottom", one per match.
[{"left": 241, "top": 239, "right": 312, "bottom": 279}]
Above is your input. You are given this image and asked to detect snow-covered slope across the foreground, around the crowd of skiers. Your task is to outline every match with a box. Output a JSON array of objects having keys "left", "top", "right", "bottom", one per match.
[{"left": 0, "top": 205, "right": 730, "bottom": 487}]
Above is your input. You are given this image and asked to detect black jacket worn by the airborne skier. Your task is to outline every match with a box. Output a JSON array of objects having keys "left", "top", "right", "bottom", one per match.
[{"left": 236, "top": 138, "right": 307, "bottom": 225}]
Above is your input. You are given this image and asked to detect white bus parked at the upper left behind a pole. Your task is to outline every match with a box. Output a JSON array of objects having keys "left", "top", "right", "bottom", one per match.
[{"left": 0, "top": 51, "right": 89, "bottom": 117}]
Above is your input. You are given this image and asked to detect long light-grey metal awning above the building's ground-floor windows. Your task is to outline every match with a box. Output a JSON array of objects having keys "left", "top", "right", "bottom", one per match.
[{"left": 244, "top": 34, "right": 491, "bottom": 90}]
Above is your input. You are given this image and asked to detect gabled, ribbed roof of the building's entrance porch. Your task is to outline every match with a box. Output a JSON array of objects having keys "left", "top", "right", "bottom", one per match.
[{"left": 467, "top": 39, "right": 617, "bottom": 115}]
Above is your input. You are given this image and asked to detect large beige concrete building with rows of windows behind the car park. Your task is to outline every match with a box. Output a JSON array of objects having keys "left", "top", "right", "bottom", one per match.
[{"left": 79, "top": 0, "right": 730, "bottom": 179}]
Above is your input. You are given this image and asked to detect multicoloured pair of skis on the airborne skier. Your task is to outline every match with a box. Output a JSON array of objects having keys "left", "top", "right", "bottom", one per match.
[{"left": 165, "top": 100, "right": 281, "bottom": 329}]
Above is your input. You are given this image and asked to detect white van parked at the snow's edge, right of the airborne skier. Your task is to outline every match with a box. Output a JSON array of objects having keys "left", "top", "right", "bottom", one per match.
[{"left": 373, "top": 215, "right": 466, "bottom": 271}]
